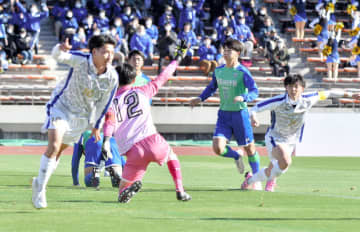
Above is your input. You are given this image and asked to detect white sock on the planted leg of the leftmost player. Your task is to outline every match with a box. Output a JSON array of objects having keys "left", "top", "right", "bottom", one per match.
[{"left": 37, "top": 155, "right": 56, "bottom": 192}]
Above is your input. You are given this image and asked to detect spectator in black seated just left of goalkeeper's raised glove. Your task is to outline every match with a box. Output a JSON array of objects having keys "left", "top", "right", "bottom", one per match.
[{"left": 158, "top": 22, "right": 177, "bottom": 74}]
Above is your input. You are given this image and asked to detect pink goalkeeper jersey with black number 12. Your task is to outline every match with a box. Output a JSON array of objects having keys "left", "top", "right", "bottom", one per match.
[{"left": 104, "top": 61, "right": 177, "bottom": 154}]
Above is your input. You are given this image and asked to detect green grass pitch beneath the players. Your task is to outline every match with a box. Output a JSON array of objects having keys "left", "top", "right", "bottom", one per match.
[{"left": 0, "top": 155, "right": 360, "bottom": 232}]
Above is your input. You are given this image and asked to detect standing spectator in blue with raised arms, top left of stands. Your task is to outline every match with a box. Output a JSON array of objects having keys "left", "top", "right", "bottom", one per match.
[{"left": 16, "top": 0, "right": 49, "bottom": 54}]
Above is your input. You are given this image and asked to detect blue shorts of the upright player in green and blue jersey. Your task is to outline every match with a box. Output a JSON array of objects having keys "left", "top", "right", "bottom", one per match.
[{"left": 214, "top": 109, "right": 254, "bottom": 146}]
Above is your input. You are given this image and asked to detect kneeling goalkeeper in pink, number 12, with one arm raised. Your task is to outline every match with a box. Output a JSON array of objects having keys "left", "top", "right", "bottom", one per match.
[{"left": 104, "top": 42, "right": 191, "bottom": 203}]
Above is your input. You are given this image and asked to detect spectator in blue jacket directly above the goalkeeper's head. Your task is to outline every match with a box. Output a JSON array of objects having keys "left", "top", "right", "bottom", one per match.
[{"left": 130, "top": 25, "right": 154, "bottom": 63}]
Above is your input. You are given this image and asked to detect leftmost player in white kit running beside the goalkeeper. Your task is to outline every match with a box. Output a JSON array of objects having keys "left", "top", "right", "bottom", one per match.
[{"left": 32, "top": 35, "right": 118, "bottom": 208}]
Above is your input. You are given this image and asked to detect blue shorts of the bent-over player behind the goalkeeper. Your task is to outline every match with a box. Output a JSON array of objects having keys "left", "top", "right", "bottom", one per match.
[{"left": 85, "top": 137, "right": 125, "bottom": 168}]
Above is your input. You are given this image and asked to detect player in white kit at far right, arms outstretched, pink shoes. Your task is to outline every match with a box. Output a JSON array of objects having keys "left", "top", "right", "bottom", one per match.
[{"left": 241, "top": 74, "right": 355, "bottom": 192}]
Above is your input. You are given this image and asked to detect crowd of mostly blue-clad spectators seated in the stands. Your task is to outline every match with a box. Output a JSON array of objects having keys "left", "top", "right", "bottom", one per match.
[{"left": 0, "top": 0, "right": 289, "bottom": 75}]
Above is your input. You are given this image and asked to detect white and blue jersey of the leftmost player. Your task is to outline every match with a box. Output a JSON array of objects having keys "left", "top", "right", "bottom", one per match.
[{"left": 46, "top": 44, "right": 118, "bottom": 128}]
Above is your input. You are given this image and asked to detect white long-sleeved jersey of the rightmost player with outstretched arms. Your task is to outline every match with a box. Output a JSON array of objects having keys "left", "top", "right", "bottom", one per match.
[{"left": 250, "top": 91, "right": 344, "bottom": 144}]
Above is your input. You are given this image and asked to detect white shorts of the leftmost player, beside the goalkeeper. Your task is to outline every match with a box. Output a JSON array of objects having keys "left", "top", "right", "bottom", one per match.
[{"left": 41, "top": 107, "right": 90, "bottom": 145}]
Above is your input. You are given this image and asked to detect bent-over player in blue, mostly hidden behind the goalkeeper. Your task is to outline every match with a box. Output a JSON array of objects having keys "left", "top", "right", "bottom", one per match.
[{"left": 71, "top": 130, "right": 125, "bottom": 188}]
